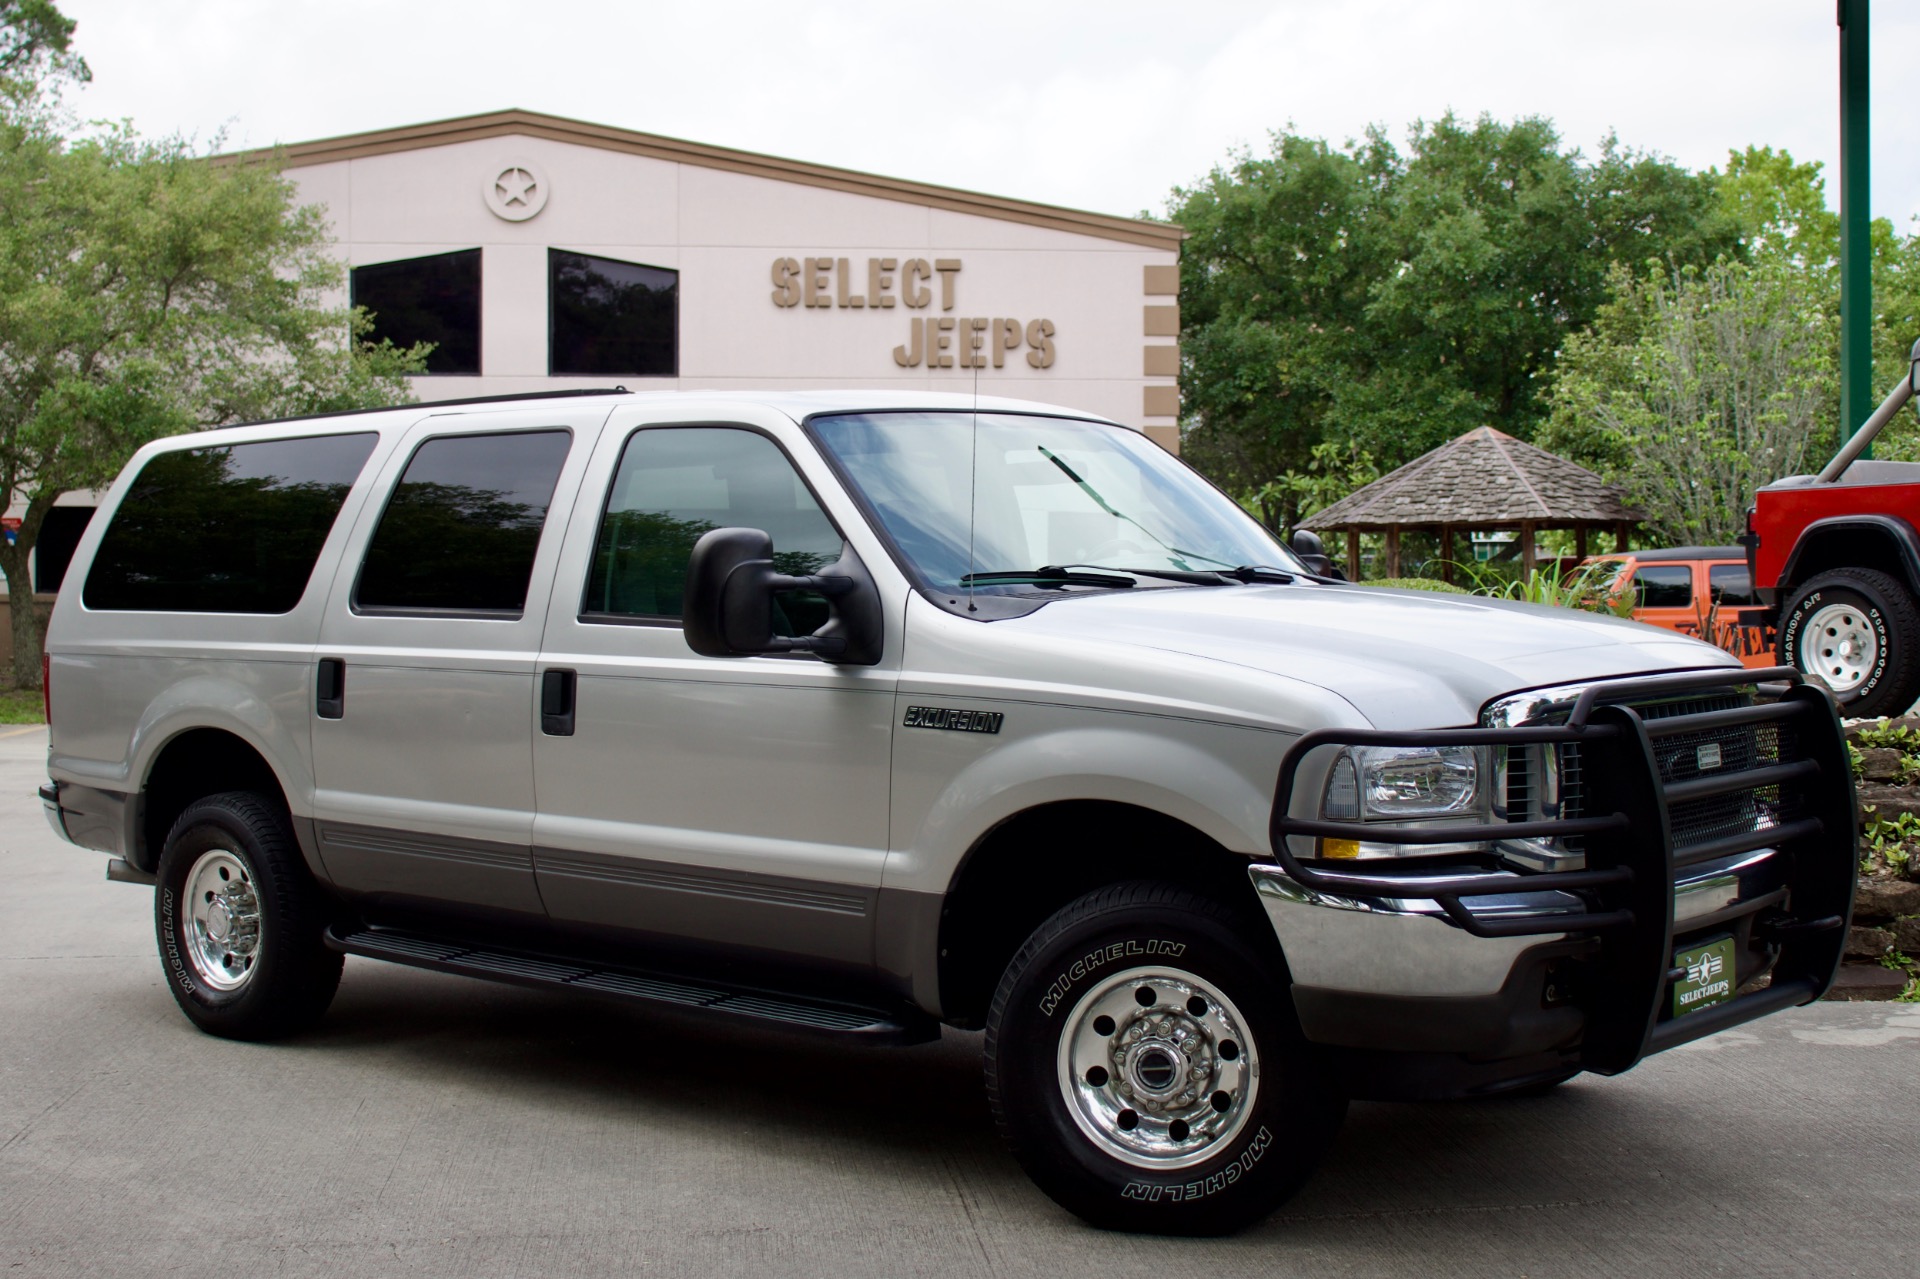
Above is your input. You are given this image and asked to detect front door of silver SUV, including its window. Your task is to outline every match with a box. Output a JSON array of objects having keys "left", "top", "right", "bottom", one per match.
[{"left": 534, "top": 409, "right": 899, "bottom": 968}]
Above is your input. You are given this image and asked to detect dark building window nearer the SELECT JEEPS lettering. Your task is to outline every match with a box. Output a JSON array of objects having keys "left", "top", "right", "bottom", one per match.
[{"left": 547, "top": 250, "right": 680, "bottom": 378}]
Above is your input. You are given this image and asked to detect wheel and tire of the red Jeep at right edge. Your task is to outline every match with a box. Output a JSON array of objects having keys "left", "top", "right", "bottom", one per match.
[{"left": 1780, "top": 568, "right": 1920, "bottom": 718}]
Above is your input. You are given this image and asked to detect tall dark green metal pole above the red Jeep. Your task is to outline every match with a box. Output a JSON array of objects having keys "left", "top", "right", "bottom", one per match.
[{"left": 1836, "top": 0, "right": 1874, "bottom": 457}]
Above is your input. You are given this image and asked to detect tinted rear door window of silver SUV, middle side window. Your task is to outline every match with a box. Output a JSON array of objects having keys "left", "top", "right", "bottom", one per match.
[{"left": 353, "top": 430, "right": 572, "bottom": 615}]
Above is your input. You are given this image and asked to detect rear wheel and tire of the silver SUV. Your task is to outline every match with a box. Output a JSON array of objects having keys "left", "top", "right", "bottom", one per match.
[{"left": 154, "top": 791, "right": 342, "bottom": 1039}]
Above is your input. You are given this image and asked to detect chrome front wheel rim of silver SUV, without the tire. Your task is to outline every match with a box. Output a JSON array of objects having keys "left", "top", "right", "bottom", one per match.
[{"left": 1060, "top": 968, "right": 1260, "bottom": 1170}]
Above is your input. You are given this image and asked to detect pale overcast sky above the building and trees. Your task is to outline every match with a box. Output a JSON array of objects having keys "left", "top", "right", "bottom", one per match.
[{"left": 61, "top": 0, "right": 1920, "bottom": 232}]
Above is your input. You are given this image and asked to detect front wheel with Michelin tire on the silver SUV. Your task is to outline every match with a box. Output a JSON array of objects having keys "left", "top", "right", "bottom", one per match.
[{"left": 987, "top": 883, "right": 1346, "bottom": 1235}]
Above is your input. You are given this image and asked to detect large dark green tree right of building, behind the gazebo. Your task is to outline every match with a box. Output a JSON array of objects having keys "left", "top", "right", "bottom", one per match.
[{"left": 1169, "top": 113, "right": 1740, "bottom": 522}]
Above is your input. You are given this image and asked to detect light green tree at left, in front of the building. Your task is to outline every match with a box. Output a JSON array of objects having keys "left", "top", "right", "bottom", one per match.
[{"left": 0, "top": 2, "right": 426, "bottom": 688}]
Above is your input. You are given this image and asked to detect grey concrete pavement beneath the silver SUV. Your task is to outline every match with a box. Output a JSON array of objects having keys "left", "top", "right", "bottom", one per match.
[{"left": 0, "top": 728, "right": 1920, "bottom": 1279}]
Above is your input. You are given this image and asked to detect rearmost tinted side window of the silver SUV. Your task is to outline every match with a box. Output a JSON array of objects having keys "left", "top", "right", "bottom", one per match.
[{"left": 82, "top": 432, "right": 378, "bottom": 613}]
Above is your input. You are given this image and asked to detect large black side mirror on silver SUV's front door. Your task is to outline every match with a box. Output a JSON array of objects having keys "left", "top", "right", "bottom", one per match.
[{"left": 684, "top": 528, "right": 885, "bottom": 666}]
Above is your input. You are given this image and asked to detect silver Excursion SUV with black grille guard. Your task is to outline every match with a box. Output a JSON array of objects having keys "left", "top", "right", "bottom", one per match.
[{"left": 42, "top": 392, "right": 1855, "bottom": 1233}]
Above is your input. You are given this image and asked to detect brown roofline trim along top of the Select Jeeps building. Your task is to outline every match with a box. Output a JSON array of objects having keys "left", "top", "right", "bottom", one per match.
[{"left": 221, "top": 108, "right": 1187, "bottom": 250}]
